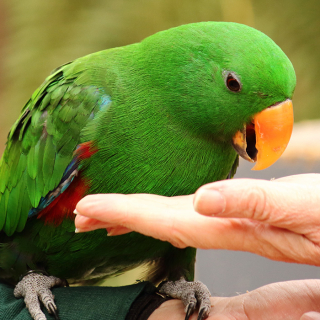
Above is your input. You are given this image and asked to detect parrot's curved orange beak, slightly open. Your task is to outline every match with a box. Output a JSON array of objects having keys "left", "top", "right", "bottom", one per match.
[{"left": 232, "top": 99, "right": 293, "bottom": 170}]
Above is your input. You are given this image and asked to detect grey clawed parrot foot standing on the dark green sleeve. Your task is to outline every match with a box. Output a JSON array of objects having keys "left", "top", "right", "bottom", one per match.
[{"left": 13, "top": 271, "right": 67, "bottom": 320}]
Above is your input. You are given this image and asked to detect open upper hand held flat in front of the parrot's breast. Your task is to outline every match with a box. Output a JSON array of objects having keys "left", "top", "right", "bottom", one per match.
[{"left": 75, "top": 174, "right": 320, "bottom": 265}]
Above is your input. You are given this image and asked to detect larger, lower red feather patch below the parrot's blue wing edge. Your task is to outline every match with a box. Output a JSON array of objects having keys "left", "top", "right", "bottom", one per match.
[{"left": 37, "top": 173, "right": 90, "bottom": 226}]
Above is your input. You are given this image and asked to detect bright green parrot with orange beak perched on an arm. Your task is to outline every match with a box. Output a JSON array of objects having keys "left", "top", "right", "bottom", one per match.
[{"left": 0, "top": 22, "right": 296, "bottom": 320}]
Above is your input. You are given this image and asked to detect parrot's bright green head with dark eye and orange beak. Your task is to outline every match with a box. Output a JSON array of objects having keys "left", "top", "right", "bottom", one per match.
[{"left": 141, "top": 22, "right": 296, "bottom": 170}]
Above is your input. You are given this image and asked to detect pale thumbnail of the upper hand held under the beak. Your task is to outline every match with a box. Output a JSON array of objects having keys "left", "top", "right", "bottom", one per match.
[{"left": 193, "top": 188, "right": 226, "bottom": 216}]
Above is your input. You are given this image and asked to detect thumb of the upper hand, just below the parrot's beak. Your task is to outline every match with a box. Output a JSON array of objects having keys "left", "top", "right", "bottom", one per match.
[{"left": 194, "top": 175, "right": 320, "bottom": 230}]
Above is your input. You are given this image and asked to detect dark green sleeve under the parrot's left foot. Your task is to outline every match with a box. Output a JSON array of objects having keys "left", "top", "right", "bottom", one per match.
[{"left": 0, "top": 282, "right": 155, "bottom": 320}]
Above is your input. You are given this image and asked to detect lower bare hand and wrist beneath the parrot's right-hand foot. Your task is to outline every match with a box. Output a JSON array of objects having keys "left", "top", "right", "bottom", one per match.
[{"left": 149, "top": 280, "right": 320, "bottom": 320}]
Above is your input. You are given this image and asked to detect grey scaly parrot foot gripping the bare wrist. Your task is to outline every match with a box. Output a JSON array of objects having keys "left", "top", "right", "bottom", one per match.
[{"left": 159, "top": 278, "right": 211, "bottom": 320}]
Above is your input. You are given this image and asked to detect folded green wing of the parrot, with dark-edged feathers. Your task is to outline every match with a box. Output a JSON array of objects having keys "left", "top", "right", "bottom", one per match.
[{"left": 0, "top": 60, "right": 111, "bottom": 235}]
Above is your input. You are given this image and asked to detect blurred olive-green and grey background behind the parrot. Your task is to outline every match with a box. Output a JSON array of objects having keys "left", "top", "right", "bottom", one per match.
[{"left": 0, "top": 0, "right": 320, "bottom": 295}]
